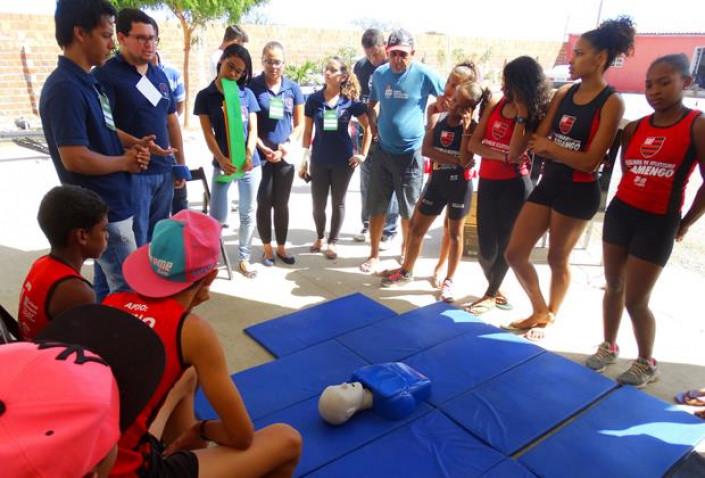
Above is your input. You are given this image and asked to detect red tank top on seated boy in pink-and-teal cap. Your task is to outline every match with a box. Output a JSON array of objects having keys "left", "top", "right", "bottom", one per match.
[{"left": 103, "top": 292, "right": 188, "bottom": 477}]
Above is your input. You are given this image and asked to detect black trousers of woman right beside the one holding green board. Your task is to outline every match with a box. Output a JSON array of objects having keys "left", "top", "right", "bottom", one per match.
[{"left": 257, "top": 160, "right": 295, "bottom": 245}]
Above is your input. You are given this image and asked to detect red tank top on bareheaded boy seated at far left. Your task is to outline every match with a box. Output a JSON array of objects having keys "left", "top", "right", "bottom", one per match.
[{"left": 17, "top": 255, "right": 88, "bottom": 340}]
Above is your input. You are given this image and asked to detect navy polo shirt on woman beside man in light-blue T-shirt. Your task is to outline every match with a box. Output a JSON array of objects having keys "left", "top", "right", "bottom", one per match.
[{"left": 304, "top": 90, "right": 367, "bottom": 166}]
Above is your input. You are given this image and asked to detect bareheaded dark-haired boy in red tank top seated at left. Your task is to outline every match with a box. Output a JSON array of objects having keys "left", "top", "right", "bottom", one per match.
[{"left": 18, "top": 185, "right": 108, "bottom": 340}]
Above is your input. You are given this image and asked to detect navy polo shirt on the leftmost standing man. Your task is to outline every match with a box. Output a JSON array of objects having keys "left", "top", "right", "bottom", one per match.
[{"left": 39, "top": 56, "right": 133, "bottom": 222}]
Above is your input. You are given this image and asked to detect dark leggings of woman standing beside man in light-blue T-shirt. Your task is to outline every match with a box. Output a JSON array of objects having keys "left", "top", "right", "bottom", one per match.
[{"left": 311, "top": 162, "right": 354, "bottom": 243}]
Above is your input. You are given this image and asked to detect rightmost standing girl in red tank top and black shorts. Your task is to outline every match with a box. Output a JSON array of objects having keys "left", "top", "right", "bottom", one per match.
[{"left": 586, "top": 54, "right": 705, "bottom": 387}]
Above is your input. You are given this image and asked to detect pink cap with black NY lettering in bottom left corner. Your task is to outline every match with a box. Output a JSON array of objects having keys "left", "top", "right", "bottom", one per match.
[{"left": 0, "top": 342, "right": 120, "bottom": 478}]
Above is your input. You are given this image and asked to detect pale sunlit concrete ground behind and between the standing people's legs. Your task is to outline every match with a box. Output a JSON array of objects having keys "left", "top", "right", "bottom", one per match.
[{"left": 0, "top": 132, "right": 705, "bottom": 450}]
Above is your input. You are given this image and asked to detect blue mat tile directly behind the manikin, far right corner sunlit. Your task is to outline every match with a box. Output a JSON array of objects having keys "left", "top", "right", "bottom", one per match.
[{"left": 336, "top": 302, "right": 499, "bottom": 363}]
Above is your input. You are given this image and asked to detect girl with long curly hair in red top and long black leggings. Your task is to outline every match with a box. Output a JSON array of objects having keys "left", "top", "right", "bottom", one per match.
[{"left": 468, "top": 56, "right": 549, "bottom": 315}]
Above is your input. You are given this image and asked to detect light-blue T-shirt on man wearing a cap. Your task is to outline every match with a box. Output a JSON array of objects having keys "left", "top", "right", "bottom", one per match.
[{"left": 370, "top": 62, "right": 444, "bottom": 154}]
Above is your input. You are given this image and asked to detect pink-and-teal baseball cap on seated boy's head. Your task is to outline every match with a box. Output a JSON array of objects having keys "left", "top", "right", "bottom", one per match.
[{"left": 122, "top": 209, "right": 221, "bottom": 298}]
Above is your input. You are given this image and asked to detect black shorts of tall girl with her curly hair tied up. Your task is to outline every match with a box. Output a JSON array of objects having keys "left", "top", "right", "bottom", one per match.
[{"left": 527, "top": 175, "right": 600, "bottom": 221}]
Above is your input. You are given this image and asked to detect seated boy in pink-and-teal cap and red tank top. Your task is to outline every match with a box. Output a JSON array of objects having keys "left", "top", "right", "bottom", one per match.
[{"left": 104, "top": 210, "right": 301, "bottom": 478}]
